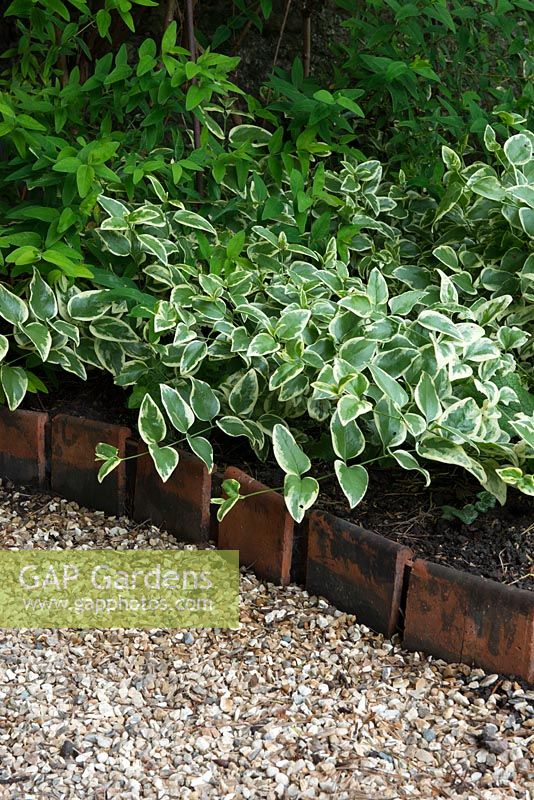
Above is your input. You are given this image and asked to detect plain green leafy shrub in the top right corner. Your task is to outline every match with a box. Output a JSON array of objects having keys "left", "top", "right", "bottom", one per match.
[{"left": 335, "top": 0, "right": 534, "bottom": 187}]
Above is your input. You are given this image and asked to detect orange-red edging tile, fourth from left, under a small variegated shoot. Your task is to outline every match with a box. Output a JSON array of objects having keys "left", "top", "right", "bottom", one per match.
[{"left": 218, "top": 467, "right": 294, "bottom": 585}]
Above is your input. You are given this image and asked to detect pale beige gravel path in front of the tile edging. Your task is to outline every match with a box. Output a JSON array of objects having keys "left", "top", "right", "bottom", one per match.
[{"left": 0, "top": 487, "right": 534, "bottom": 800}]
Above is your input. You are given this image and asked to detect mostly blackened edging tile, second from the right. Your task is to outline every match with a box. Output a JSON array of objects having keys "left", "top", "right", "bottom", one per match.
[{"left": 306, "top": 511, "right": 413, "bottom": 636}]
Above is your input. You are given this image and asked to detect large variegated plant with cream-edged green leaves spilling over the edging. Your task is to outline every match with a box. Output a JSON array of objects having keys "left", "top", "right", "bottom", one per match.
[{"left": 0, "top": 129, "right": 534, "bottom": 520}]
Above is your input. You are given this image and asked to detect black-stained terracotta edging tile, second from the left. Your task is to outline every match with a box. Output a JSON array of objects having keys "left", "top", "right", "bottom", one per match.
[{"left": 50, "top": 414, "right": 131, "bottom": 515}]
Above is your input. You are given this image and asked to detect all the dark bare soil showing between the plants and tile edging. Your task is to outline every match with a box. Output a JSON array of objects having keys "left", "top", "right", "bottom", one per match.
[{"left": 24, "top": 375, "right": 534, "bottom": 590}]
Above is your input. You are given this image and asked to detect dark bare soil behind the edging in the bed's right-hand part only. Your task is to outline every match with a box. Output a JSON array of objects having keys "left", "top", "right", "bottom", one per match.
[{"left": 216, "top": 432, "right": 534, "bottom": 590}]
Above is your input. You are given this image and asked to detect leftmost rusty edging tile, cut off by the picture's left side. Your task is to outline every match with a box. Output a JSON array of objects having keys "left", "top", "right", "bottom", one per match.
[{"left": 0, "top": 406, "right": 48, "bottom": 489}]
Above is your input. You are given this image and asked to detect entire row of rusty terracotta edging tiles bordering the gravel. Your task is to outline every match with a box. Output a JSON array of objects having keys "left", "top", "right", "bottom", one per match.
[{"left": 0, "top": 416, "right": 534, "bottom": 683}]
